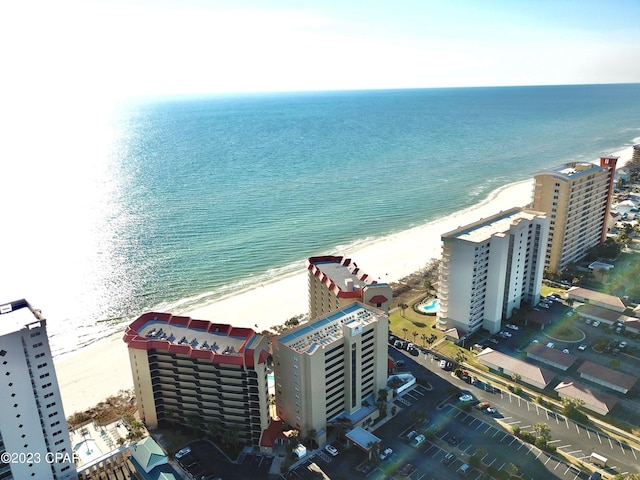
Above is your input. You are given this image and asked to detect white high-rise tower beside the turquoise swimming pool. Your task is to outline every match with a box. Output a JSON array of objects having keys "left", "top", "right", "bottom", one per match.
[{"left": 437, "top": 208, "right": 549, "bottom": 335}]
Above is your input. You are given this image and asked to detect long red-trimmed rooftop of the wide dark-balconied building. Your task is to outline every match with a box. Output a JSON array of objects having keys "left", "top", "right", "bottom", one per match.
[{"left": 124, "top": 312, "right": 266, "bottom": 363}]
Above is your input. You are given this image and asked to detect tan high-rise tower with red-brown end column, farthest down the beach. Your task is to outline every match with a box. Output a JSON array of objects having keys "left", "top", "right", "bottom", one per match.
[{"left": 532, "top": 157, "right": 618, "bottom": 272}]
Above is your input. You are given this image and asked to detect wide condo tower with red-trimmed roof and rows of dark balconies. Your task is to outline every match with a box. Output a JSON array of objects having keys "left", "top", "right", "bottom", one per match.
[{"left": 124, "top": 312, "right": 269, "bottom": 446}]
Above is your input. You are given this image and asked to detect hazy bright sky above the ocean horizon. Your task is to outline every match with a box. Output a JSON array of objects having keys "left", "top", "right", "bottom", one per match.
[{"left": 0, "top": 0, "right": 640, "bottom": 99}]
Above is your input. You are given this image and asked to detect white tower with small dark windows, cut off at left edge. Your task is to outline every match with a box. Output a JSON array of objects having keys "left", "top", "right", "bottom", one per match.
[{"left": 0, "top": 300, "right": 77, "bottom": 480}]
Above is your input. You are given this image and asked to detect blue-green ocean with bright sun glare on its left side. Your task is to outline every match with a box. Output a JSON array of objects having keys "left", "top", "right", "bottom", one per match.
[{"left": 0, "top": 84, "right": 640, "bottom": 355}]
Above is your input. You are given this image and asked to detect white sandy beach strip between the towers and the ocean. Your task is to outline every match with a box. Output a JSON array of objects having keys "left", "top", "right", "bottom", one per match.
[{"left": 56, "top": 142, "right": 632, "bottom": 416}]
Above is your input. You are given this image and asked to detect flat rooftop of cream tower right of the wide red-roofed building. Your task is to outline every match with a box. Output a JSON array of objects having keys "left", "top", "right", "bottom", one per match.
[{"left": 278, "top": 302, "right": 386, "bottom": 355}]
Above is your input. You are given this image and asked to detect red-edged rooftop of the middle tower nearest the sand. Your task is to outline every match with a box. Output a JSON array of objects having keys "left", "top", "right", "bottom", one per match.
[{"left": 307, "top": 255, "right": 384, "bottom": 303}]
